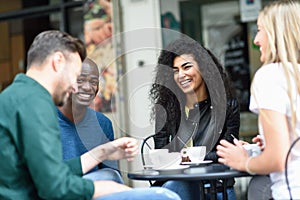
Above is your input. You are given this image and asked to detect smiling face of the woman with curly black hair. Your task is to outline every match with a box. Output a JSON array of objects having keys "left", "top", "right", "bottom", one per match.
[{"left": 173, "top": 54, "right": 206, "bottom": 97}]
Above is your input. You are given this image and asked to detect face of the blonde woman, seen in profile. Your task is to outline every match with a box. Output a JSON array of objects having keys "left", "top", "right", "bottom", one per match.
[{"left": 254, "top": 17, "right": 268, "bottom": 62}]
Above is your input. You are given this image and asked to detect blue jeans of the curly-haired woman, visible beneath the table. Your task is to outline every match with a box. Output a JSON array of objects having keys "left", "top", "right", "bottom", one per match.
[{"left": 162, "top": 181, "right": 236, "bottom": 200}]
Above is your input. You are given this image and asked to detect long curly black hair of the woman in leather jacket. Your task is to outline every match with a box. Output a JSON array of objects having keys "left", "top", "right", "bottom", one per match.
[{"left": 149, "top": 37, "right": 234, "bottom": 130}]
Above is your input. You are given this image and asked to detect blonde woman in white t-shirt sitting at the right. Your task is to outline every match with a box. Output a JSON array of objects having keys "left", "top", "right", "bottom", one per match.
[{"left": 217, "top": 0, "right": 300, "bottom": 199}]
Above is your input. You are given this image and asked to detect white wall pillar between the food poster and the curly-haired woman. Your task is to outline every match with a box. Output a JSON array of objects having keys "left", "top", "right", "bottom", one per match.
[{"left": 119, "top": 0, "right": 162, "bottom": 187}]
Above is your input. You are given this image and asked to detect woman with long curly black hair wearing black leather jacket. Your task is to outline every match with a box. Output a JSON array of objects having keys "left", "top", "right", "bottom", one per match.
[{"left": 150, "top": 37, "right": 240, "bottom": 199}]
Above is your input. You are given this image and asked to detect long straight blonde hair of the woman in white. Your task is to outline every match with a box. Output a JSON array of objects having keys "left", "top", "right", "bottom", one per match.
[{"left": 258, "top": 0, "right": 300, "bottom": 133}]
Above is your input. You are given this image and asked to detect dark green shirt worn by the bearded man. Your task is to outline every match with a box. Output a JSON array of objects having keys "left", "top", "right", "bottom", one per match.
[{"left": 0, "top": 74, "right": 94, "bottom": 200}]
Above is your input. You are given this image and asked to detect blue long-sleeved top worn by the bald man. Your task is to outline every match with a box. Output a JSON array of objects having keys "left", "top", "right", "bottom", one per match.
[{"left": 57, "top": 108, "right": 117, "bottom": 170}]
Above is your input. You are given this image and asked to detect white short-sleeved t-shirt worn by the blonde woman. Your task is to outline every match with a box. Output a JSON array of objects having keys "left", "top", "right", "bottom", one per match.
[{"left": 250, "top": 63, "right": 300, "bottom": 199}]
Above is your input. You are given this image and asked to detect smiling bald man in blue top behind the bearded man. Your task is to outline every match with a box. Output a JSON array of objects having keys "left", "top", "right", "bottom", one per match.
[{"left": 57, "top": 58, "right": 123, "bottom": 183}]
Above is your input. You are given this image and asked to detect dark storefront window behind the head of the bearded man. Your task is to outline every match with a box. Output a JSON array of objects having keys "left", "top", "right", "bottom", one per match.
[{"left": 0, "top": 0, "right": 83, "bottom": 92}]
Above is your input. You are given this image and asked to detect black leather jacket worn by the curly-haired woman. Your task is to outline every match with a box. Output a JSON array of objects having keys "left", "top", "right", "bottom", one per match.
[{"left": 154, "top": 98, "right": 240, "bottom": 162}]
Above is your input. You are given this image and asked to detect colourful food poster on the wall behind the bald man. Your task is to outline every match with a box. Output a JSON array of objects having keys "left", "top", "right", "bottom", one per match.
[{"left": 84, "top": 0, "right": 117, "bottom": 113}]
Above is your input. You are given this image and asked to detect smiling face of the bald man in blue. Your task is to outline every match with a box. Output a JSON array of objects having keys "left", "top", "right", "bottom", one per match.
[{"left": 72, "top": 60, "right": 99, "bottom": 106}]
